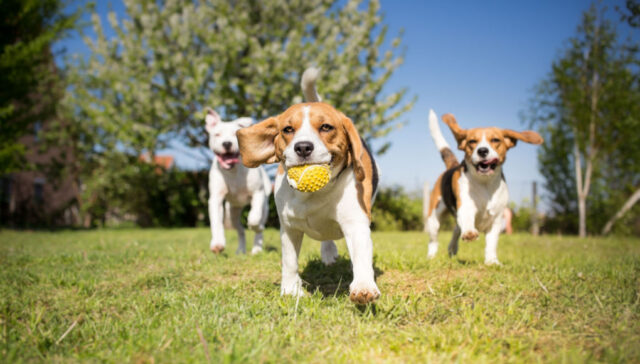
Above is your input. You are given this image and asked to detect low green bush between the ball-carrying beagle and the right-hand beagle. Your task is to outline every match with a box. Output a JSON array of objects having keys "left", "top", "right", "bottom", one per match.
[{"left": 371, "top": 186, "right": 423, "bottom": 231}]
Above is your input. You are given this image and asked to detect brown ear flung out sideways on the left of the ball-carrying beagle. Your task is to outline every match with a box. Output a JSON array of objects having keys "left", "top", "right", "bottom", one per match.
[{"left": 236, "top": 117, "right": 278, "bottom": 168}]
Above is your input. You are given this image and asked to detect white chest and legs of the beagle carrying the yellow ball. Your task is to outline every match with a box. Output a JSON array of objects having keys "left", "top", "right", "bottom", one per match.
[{"left": 275, "top": 167, "right": 380, "bottom": 295}]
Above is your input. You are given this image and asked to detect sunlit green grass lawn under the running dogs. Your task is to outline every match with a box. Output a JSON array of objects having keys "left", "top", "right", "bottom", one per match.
[{"left": 0, "top": 229, "right": 640, "bottom": 363}]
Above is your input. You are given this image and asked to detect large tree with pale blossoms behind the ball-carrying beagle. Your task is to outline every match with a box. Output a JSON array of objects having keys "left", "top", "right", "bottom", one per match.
[{"left": 60, "top": 0, "right": 413, "bottom": 226}]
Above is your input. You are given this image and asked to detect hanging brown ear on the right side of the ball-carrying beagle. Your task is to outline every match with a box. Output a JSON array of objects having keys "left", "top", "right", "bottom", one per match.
[{"left": 343, "top": 116, "right": 374, "bottom": 221}]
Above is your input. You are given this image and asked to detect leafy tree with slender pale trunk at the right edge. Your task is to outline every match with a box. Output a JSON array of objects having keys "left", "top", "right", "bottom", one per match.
[{"left": 530, "top": 6, "right": 640, "bottom": 237}]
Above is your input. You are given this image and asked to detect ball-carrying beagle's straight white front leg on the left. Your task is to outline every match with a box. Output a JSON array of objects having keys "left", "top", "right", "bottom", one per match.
[{"left": 280, "top": 229, "right": 304, "bottom": 296}]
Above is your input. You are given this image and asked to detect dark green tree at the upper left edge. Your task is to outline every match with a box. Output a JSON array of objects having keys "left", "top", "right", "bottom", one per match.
[{"left": 0, "top": 0, "right": 80, "bottom": 175}]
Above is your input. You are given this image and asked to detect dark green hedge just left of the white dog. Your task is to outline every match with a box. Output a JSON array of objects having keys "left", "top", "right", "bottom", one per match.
[{"left": 82, "top": 153, "right": 208, "bottom": 226}]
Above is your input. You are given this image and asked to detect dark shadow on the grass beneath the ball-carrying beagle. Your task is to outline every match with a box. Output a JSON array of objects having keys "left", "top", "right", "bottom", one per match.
[{"left": 300, "top": 256, "right": 384, "bottom": 297}]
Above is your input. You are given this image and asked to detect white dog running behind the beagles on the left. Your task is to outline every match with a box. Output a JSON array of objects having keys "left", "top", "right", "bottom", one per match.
[{"left": 205, "top": 109, "right": 271, "bottom": 254}]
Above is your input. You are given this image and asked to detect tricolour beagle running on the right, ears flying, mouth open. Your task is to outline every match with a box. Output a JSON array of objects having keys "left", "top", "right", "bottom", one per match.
[{"left": 427, "top": 110, "right": 543, "bottom": 265}]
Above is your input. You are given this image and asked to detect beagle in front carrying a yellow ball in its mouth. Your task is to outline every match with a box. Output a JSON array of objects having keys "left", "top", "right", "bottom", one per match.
[{"left": 237, "top": 70, "right": 380, "bottom": 304}]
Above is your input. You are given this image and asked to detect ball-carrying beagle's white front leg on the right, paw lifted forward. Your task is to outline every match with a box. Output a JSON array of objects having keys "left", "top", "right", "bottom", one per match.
[{"left": 340, "top": 221, "right": 380, "bottom": 305}]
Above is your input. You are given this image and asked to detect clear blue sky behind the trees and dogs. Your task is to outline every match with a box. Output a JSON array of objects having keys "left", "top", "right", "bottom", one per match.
[{"left": 60, "top": 0, "right": 626, "bottom": 208}]
